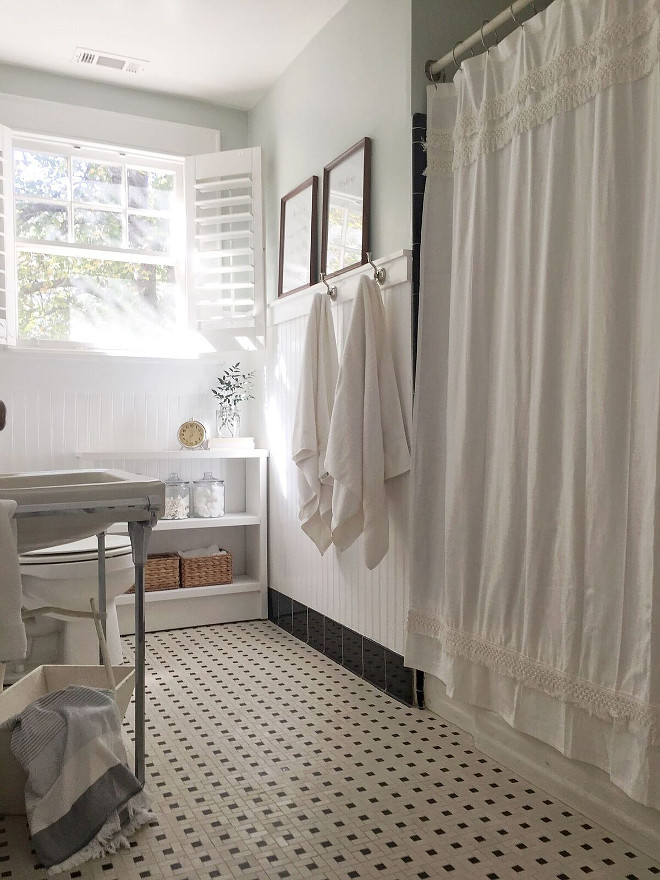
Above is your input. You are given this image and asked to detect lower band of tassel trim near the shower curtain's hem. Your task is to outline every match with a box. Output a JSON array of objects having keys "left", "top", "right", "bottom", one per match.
[{"left": 407, "top": 610, "right": 660, "bottom": 745}]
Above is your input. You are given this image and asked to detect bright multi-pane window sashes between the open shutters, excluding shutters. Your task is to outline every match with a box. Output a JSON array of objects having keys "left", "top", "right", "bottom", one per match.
[{"left": 13, "top": 139, "right": 187, "bottom": 350}]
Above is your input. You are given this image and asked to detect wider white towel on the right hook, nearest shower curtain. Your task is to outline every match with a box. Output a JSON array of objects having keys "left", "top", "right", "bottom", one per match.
[{"left": 325, "top": 276, "right": 410, "bottom": 570}]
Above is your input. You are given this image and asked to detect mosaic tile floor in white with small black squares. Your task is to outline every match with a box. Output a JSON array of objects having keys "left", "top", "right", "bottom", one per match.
[{"left": 0, "top": 622, "right": 660, "bottom": 880}]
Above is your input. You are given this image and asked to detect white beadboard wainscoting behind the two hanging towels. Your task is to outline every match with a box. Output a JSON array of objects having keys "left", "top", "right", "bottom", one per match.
[{"left": 266, "top": 251, "right": 412, "bottom": 654}]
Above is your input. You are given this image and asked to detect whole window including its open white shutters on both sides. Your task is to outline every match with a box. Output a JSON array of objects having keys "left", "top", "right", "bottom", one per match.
[{"left": 0, "top": 126, "right": 264, "bottom": 357}]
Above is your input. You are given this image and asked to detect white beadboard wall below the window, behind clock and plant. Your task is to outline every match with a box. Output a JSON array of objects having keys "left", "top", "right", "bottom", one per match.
[{"left": 0, "top": 351, "right": 262, "bottom": 472}]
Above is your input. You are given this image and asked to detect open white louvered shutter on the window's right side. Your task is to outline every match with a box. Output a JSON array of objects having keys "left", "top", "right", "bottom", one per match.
[{"left": 186, "top": 147, "right": 265, "bottom": 351}]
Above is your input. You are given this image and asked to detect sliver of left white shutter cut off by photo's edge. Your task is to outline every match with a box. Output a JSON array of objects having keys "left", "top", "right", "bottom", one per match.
[{"left": 0, "top": 126, "right": 16, "bottom": 345}]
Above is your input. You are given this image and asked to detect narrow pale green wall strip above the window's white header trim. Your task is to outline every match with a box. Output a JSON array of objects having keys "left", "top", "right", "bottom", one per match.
[{"left": 0, "top": 64, "right": 248, "bottom": 150}]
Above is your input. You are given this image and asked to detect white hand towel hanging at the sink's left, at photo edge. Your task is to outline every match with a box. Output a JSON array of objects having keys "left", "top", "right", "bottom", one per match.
[{"left": 0, "top": 501, "right": 27, "bottom": 663}]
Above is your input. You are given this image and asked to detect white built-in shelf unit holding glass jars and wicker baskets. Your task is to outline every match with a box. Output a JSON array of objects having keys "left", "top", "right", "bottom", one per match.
[{"left": 77, "top": 449, "right": 268, "bottom": 635}]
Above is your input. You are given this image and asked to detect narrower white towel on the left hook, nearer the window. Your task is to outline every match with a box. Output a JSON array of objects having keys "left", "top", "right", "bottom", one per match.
[{"left": 292, "top": 294, "right": 338, "bottom": 555}]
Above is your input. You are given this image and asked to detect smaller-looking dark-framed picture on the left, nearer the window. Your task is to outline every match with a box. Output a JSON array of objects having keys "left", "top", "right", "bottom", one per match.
[{"left": 277, "top": 175, "right": 319, "bottom": 296}]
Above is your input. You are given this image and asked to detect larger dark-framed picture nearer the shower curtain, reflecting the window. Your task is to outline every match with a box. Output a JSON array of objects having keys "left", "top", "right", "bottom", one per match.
[{"left": 321, "top": 138, "right": 371, "bottom": 277}]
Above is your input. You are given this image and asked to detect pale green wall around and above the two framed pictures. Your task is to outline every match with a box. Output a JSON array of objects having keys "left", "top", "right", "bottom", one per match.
[{"left": 249, "top": 0, "right": 411, "bottom": 299}]
